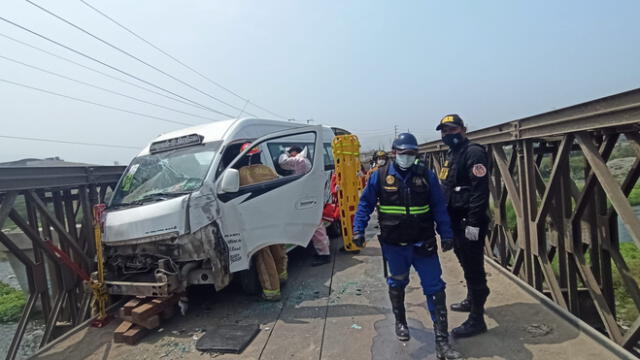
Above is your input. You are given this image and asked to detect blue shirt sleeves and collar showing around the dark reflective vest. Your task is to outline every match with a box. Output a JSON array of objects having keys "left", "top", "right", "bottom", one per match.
[{"left": 353, "top": 163, "right": 453, "bottom": 239}]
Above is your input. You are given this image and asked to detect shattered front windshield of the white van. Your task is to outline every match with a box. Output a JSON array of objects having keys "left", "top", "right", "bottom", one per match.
[{"left": 109, "top": 143, "right": 219, "bottom": 207}]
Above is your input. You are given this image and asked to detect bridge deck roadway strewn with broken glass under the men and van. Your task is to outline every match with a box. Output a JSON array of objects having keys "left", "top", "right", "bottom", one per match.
[{"left": 35, "top": 241, "right": 618, "bottom": 360}]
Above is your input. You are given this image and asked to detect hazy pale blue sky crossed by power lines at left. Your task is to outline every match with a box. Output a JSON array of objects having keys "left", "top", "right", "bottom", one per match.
[{"left": 0, "top": 0, "right": 640, "bottom": 165}]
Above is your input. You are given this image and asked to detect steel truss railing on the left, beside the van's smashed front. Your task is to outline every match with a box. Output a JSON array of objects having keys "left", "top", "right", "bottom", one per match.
[{"left": 0, "top": 166, "right": 125, "bottom": 359}]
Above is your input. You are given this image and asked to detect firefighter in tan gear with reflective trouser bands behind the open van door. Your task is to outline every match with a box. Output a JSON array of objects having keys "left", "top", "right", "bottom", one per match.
[{"left": 238, "top": 143, "right": 289, "bottom": 301}]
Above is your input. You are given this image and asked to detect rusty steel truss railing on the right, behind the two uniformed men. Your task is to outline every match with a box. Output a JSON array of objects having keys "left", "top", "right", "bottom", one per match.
[{"left": 420, "top": 89, "right": 640, "bottom": 354}]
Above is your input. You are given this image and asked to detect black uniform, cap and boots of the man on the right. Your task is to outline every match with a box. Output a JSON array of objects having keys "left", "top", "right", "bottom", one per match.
[{"left": 439, "top": 117, "right": 489, "bottom": 337}]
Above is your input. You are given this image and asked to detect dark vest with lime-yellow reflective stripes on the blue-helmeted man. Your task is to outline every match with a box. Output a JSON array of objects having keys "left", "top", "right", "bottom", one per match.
[{"left": 378, "top": 164, "right": 436, "bottom": 245}]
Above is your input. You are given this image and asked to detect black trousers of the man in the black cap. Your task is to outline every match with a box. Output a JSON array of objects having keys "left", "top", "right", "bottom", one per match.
[{"left": 451, "top": 218, "right": 489, "bottom": 312}]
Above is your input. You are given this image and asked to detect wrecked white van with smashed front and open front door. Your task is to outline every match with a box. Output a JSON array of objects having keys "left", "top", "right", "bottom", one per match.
[{"left": 103, "top": 119, "right": 344, "bottom": 296}]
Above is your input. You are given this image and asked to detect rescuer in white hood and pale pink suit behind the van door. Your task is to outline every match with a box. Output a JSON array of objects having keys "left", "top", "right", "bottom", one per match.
[{"left": 278, "top": 145, "right": 331, "bottom": 266}]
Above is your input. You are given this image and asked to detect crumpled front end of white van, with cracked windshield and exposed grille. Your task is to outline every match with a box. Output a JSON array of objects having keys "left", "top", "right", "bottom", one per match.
[{"left": 103, "top": 135, "right": 231, "bottom": 297}]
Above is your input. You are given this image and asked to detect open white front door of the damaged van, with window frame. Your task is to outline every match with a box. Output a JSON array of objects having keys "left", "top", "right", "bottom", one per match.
[{"left": 215, "top": 126, "right": 325, "bottom": 272}]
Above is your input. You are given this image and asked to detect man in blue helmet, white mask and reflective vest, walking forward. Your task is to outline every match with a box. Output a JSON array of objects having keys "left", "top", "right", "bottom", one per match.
[{"left": 353, "top": 133, "right": 462, "bottom": 359}]
